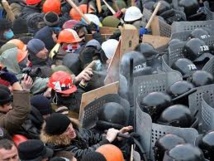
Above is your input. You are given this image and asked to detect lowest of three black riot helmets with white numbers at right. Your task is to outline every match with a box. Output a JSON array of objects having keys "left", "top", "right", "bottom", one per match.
[{"left": 171, "top": 58, "right": 197, "bottom": 78}]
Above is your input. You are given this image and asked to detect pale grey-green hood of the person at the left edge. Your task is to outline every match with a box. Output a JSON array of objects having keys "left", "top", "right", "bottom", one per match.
[{"left": 0, "top": 47, "right": 21, "bottom": 74}]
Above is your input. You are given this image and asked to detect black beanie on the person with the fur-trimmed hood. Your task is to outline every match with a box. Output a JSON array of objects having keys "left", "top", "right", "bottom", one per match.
[{"left": 44, "top": 113, "right": 71, "bottom": 135}]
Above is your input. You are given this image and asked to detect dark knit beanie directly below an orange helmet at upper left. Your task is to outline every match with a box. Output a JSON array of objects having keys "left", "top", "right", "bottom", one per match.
[{"left": 44, "top": 12, "right": 59, "bottom": 26}]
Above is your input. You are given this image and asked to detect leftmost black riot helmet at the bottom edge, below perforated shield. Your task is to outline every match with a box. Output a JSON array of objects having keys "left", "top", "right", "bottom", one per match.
[{"left": 154, "top": 134, "right": 186, "bottom": 161}]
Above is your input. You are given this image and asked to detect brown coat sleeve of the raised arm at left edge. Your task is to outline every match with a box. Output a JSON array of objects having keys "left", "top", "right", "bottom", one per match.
[{"left": 0, "top": 91, "right": 30, "bottom": 135}]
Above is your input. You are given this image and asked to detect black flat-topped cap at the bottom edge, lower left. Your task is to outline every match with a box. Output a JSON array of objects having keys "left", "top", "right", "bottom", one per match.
[{"left": 18, "top": 139, "right": 53, "bottom": 161}]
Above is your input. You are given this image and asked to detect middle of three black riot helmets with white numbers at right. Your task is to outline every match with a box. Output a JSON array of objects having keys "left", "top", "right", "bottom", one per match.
[{"left": 183, "top": 38, "right": 213, "bottom": 62}]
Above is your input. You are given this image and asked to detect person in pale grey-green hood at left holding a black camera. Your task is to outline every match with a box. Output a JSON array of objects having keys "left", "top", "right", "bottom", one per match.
[{"left": 0, "top": 44, "right": 48, "bottom": 94}]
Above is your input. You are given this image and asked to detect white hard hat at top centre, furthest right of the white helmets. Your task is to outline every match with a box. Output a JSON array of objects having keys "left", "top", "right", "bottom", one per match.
[{"left": 124, "top": 6, "right": 143, "bottom": 22}]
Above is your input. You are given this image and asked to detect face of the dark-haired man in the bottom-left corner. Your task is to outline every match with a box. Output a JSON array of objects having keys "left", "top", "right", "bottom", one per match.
[{"left": 0, "top": 145, "right": 19, "bottom": 161}]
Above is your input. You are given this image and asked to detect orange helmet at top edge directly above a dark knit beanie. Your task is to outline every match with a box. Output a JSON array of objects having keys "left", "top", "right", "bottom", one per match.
[{"left": 42, "top": 0, "right": 61, "bottom": 15}]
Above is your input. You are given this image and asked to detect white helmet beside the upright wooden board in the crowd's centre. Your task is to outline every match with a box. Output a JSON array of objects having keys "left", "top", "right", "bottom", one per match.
[{"left": 101, "top": 39, "right": 119, "bottom": 59}]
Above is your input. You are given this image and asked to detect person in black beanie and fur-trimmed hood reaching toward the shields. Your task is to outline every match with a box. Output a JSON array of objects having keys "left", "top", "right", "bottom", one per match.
[{"left": 41, "top": 113, "right": 132, "bottom": 160}]
